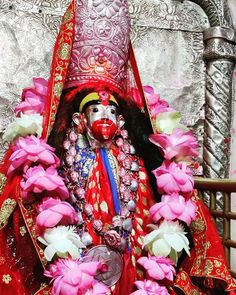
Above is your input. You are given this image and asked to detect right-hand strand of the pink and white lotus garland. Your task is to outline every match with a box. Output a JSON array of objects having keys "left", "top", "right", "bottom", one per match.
[{"left": 131, "top": 86, "right": 198, "bottom": 295}]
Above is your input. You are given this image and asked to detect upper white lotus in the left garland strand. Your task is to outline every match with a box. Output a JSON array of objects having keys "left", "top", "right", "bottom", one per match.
[{"left": 3, "top": 113, "right": 43, "bottom": 141}]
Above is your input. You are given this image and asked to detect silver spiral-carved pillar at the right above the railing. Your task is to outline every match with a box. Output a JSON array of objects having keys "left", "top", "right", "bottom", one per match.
[{"left": 203, "top": 26, "right": 236, "bottom": 178}]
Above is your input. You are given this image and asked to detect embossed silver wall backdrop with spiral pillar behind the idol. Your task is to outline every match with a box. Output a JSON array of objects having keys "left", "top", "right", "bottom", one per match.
[{"left": 0, "top": 0, "right": 235, "bottom": 177}]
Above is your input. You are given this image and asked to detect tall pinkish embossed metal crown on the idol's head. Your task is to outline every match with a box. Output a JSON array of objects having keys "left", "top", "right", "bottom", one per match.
[{"left": 64, "top": 0, "right": 130, "bottom": 93}]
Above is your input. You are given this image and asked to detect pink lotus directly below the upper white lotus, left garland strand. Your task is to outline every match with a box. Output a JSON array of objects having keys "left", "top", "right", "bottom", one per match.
[{"left": 7, "top": 135, "right": 60, "bottom": 175}]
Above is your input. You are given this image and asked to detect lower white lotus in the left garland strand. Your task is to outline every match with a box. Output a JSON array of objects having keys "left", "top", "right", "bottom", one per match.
[{"left": 38, "top": 225, "right": 86, "bottom": 261}]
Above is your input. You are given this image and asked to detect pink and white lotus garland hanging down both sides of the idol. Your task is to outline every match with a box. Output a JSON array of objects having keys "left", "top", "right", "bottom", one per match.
[{"left": 4, "top": 78, "right": 198, "bottom": 295}]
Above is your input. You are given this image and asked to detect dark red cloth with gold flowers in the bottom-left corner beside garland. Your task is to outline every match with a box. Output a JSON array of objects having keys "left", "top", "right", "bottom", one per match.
[{"left": 0, "top": 208, "right": 44, "bottom": 295}]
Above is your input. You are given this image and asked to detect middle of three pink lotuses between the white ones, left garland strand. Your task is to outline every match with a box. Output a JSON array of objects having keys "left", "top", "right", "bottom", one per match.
[{"left": 21, "top": 165, "right": 69, "bottom": 200}]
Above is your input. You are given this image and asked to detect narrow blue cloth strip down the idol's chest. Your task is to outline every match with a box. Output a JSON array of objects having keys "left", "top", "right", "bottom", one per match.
[{"left": 100, "top": 148, "right": 121, "bottom": 214}]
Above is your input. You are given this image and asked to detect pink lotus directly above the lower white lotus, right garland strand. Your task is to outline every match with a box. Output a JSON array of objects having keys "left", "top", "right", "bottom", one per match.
[{"left": 150, "top": 193, "right": 196, "bottom": 225}]
